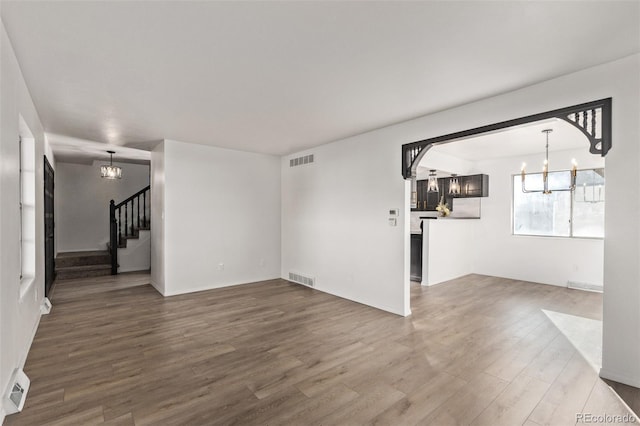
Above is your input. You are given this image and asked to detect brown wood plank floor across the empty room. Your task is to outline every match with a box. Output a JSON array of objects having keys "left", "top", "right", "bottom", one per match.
[{"left": 6, "top": 274, "right": 637, "bottom": 426}]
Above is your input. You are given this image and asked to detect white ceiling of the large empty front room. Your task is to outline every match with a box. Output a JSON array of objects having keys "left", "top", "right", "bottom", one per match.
[{"left": 1, "top": 0, "right": 640, "bottom": 155}]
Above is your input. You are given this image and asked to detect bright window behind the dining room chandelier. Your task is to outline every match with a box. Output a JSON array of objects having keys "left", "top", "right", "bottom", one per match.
[{"left": 513, "top": 168, "right": 605, "bottom": 238}]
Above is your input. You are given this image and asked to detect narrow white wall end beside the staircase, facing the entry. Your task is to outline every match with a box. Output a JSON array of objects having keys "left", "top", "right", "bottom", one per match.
[{"left": 151, "top": 142, "right": 165, "bottom": 294}]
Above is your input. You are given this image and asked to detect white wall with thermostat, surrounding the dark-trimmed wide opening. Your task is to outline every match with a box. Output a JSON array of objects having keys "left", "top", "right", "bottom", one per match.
[{"left": 282, "top": 55, "right": 640, "bottom": 387}]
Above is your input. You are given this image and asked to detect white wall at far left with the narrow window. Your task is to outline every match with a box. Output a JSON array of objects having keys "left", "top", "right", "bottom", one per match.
[{"left": 0, "top": 23, "right": 50, "bottom": 423}]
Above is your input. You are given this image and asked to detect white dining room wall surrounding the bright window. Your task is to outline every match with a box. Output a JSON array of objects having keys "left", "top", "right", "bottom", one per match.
[{"left": 474, "top": 148, "right": 615, "bottom": 287}]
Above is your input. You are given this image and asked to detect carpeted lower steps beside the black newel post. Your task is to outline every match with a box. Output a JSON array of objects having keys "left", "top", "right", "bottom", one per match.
[{"left": 56, "top": 250, "right": 111, "bottom": 280}]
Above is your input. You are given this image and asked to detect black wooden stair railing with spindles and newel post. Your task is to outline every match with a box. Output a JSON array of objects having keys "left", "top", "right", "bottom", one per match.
[{"left": 109, "top": 185, "right": 151, "bottom": 275}]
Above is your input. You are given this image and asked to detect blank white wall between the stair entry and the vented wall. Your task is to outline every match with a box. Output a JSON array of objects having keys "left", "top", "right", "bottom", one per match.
[{"left": 151, "top": 140, "right": 280, "bottom": 295}]
